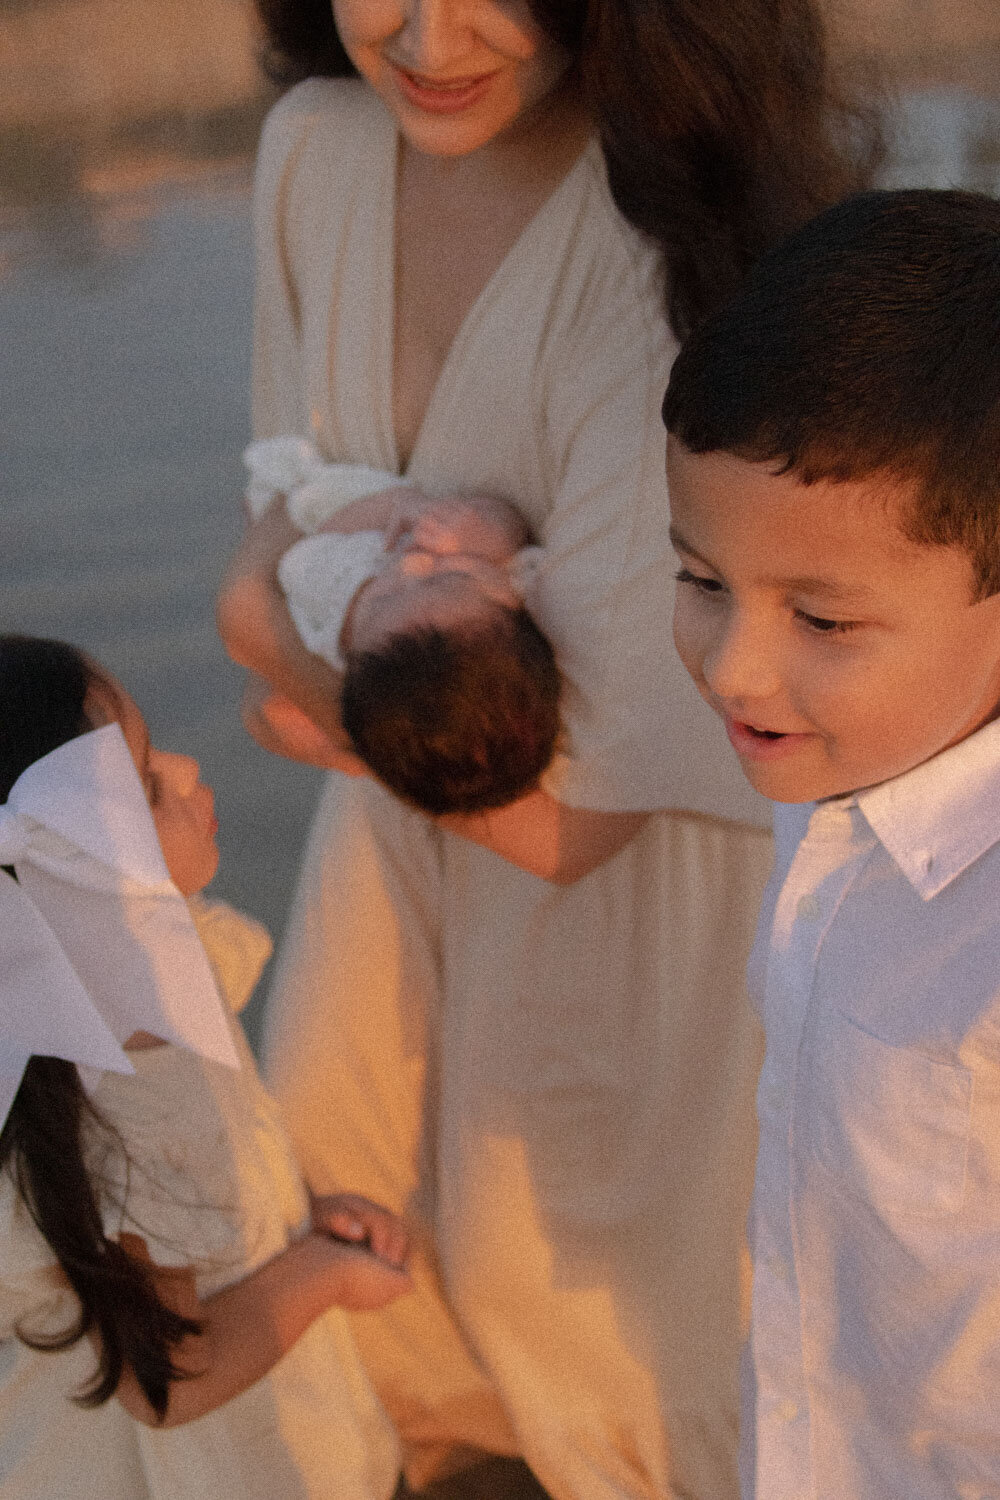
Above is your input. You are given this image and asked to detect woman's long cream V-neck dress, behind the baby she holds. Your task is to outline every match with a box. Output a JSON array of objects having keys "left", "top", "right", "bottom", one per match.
[{"left": 255, "top": 80, "right": 769, "bottom": 1500}]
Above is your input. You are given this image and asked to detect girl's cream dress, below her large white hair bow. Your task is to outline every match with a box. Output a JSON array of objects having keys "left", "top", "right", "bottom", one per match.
[{"left": 0, "top": 902, "right": 399, "bottom": 1500}]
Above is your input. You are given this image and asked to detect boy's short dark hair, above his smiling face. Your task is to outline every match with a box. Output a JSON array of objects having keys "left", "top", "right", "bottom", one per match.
[{"left": 663, "top": 189, "right": 1000, "bottom": 599}]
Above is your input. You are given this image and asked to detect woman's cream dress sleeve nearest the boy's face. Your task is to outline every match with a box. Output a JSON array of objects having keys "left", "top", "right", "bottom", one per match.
[{"left": 529, "top": 220, "right": 769, "bottom": 825}]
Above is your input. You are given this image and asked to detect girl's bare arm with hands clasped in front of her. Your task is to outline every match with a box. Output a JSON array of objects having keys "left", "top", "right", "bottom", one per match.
[{"left": 117, "top": 1196, "right": 411, "bottom": 1428}]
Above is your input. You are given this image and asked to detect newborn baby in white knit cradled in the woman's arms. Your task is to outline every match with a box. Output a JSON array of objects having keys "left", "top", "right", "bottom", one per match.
[{"left": 244, "top": 438, "right": 559, "bottom": 815}]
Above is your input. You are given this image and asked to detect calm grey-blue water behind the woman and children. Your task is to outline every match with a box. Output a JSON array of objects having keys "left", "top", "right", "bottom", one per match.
[{"left": 0, "top": 90, "right": 1000, "bottom": 1031}]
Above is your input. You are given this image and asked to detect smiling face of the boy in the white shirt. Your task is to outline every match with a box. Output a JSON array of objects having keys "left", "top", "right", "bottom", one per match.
[{"left": 667, "top": 438, "right": 1000, "bottom": 803}]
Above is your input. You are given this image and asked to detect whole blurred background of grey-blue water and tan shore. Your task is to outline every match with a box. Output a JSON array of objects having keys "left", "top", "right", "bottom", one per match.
[{"left": 0, "top": 0, "right": 1000, "bottom": 1035}]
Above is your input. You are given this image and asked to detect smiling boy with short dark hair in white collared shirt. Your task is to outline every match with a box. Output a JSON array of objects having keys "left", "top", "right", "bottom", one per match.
[{"left": 664, "top": 191, "right": 1000, "bottom": 1500}]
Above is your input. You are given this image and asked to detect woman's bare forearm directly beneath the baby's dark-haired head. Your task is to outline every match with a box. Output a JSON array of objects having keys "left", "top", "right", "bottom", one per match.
[{"left": 436, "top": 791, "right": 652, "bottom": 885}]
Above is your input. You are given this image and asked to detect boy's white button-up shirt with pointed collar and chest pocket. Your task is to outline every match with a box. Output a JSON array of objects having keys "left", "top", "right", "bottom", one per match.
[{"left": 742, "top": 723, "right": 1000, "bottom": 1500}]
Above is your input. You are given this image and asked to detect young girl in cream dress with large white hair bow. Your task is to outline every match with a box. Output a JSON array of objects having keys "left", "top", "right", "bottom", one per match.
[{"left": 0, "top": 636, "right": 409, "bottom": 1500}]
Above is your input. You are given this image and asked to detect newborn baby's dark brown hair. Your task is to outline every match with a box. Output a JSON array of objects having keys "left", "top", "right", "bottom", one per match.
[{"left": 340, "top": 605, "right": 561, "bottom": 816}]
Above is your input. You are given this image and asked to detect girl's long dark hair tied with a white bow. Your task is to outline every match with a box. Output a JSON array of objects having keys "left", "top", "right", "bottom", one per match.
[{"left": 0, "top": 635, "right": 199, "bottom": 1416}]
